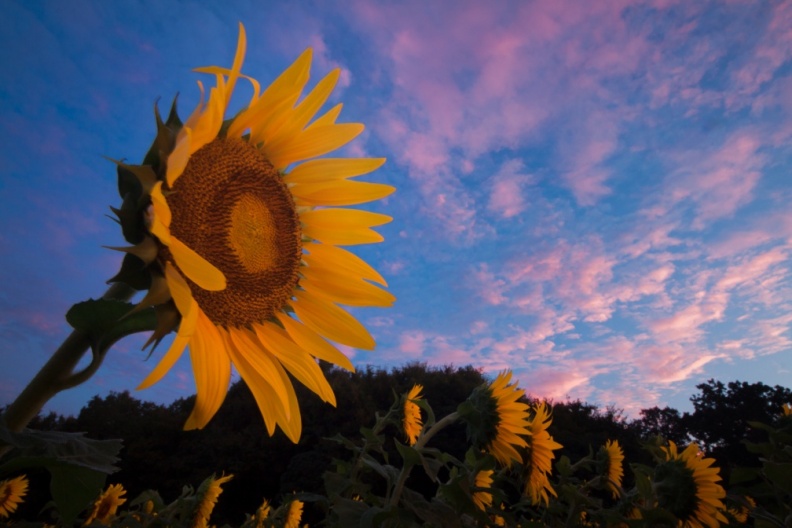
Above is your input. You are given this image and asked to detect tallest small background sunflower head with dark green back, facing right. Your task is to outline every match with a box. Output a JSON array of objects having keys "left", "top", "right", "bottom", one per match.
[{"left": 458, "top": 370, "right": 530, "bottom": 466}]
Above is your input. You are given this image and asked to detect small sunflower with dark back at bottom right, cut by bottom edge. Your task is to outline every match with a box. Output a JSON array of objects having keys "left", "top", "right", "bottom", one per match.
[{"left": 655, "top": 440, "right": 728, "bottom": 528}]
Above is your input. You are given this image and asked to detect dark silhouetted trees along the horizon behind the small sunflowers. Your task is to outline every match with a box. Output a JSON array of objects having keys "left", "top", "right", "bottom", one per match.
[{"left": 21, "top": 372, "right": 792, "bottom": 524}]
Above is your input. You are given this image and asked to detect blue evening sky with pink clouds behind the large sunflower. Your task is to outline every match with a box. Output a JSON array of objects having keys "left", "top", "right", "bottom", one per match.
[{"left": 0, "top": 0, "right": 792, "bottom": 418}]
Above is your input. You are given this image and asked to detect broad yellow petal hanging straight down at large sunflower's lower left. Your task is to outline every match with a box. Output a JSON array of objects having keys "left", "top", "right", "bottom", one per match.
[{"left": 184, "top": 312, "right": 231, "bottom": 431}]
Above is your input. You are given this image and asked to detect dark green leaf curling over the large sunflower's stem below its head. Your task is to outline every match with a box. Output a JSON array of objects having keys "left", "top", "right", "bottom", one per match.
[{"left": 66, "top": 299, "right": 157, "bottom": 354}]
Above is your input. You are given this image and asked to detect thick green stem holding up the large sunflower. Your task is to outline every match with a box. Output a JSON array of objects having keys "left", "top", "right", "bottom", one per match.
[{"left": 3, "top": 282, "right": 135, "bottom": 432}]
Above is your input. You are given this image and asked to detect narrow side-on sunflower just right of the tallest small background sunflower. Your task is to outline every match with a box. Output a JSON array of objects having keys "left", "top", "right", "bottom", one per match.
[{"left": 524, "top": 402, "right": 563, "bottom": 505}]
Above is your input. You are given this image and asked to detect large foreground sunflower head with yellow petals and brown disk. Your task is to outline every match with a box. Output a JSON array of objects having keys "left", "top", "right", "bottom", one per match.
[{"left": 111, "top": 24, "right": 394, "bottom": 442}]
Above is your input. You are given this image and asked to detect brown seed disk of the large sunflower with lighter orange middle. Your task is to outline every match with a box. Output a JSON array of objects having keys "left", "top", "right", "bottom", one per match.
[{"left": 167, "top": 138, "right": 302, "bottom": 327}]
